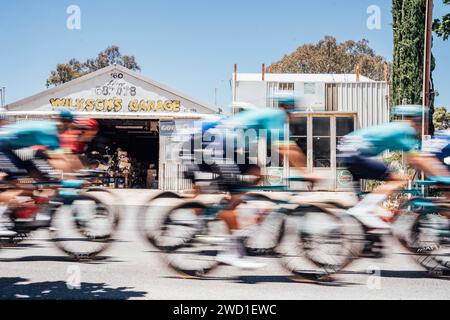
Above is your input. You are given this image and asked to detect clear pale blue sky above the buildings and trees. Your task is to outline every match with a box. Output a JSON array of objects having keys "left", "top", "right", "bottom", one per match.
[{"left": 0, "top": 0, "right": 450, "bottom": 107}]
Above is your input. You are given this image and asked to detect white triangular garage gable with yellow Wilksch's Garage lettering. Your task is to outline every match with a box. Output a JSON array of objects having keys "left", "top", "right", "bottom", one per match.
[{"left": 8, "top": 66, "right": 215, "bottom": 114}]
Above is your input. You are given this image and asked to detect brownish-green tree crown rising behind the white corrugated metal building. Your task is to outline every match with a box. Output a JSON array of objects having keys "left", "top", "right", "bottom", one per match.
[{"left": 267, "top": 36, "right": 387, "bottom": 80}]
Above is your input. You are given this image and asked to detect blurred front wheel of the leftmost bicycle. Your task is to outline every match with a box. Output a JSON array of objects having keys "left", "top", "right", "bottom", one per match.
[{"left": 50, "top": 193, "right": 119, "bottom": 260}]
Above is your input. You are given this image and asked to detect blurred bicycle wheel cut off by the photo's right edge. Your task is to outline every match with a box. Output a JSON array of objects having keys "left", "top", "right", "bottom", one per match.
[{"left": 399, "top": 212, "right": 450, "bottom": 276}]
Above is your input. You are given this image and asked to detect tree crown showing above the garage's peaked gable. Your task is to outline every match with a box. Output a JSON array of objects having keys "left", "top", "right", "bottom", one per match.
[{"left": 47, "top": 46, "right": 141, "bottom": 88}]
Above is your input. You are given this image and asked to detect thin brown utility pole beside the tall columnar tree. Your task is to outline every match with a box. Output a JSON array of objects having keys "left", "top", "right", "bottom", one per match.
[{"left": 422, "top": 0, "right": 433, "bottom": 141}]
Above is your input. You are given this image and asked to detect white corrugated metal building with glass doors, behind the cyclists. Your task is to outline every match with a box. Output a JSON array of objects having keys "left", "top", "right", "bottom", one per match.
[{"left": 232, "top": 73, "right": 389, "bottom": 191}]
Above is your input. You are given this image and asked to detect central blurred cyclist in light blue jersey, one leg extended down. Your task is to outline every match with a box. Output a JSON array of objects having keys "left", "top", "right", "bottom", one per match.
[{"left": 186, "top": 96, "right": 315, "bottom": 269}]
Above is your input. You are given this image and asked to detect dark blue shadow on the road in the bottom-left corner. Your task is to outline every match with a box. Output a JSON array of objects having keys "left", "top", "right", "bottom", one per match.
[{"left": 0, "top": 277, "right": 146, "bottom": 300}]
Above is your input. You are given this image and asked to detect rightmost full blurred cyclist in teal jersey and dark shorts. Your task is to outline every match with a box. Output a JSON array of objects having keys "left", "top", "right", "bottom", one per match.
[{"left": 338, "top": 105, "right": 448, "bottom": 229}]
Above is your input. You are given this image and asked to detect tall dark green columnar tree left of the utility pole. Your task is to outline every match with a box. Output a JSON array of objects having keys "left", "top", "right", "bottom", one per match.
[{"left": 392, "top": 0, "right": 435, "bottom": 133}]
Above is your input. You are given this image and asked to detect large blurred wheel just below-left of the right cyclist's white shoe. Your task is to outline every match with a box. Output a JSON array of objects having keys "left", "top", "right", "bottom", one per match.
[{"left": 282, "top": 205, "right": 364, "bottom": 276}]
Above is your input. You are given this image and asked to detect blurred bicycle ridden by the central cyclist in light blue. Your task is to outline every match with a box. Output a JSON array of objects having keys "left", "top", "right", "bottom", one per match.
[{"left": 144, "top": 179, "right": 362, "bottom": 278}]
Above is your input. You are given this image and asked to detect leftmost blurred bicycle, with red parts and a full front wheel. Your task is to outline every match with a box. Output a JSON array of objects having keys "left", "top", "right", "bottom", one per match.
[{"left": 0, "top": 170, "right": 120, "bottom": 261}]
